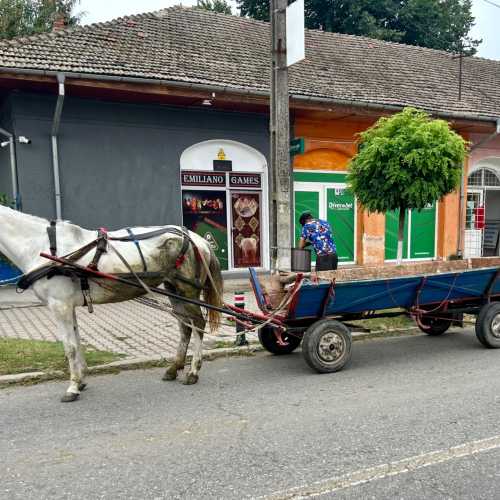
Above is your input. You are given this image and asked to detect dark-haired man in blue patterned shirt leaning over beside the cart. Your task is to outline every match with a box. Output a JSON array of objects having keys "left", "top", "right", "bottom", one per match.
[{"left": 299, "top": 212, "right": 338, "bottom": 271}]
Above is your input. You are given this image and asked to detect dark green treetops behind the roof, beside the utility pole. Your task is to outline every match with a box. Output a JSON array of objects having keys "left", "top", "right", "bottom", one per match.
[{"left": 237, "top": 0, "right": 481, "bottom": 54}]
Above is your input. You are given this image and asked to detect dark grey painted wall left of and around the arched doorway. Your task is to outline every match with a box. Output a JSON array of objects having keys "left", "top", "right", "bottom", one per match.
[{"left": 11, "top": 93, "right": 268, "bottom": 229}]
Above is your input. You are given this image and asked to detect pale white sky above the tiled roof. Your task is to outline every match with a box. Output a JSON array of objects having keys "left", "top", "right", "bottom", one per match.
[{"left": 80, "top": 0, "right": 500, "bottom": 60}]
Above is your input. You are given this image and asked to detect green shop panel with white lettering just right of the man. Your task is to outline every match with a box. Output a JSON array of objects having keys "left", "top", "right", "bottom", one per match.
[{"left": 326, "top": 186, "right": 355, "bottom": 262}]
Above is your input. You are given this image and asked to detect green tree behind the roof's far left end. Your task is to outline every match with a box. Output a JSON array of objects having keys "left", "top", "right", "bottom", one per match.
[{"left": 0, "top": 0, "right": 83, "bottom": 39}]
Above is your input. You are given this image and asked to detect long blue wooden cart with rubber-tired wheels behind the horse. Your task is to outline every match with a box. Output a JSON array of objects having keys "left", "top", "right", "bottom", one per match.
[{"left": 250, "top": 267, "right": 500, "bottom": 373}]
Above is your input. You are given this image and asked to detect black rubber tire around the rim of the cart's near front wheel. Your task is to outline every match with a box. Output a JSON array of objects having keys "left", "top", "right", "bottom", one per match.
[{"left": 302, "top": 319, "right": 352, "bottom": 373}]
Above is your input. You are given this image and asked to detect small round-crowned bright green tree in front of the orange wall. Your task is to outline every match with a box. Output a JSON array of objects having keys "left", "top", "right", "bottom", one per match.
[{"left": 347, "top": 108, "right": 467, "bottom": 263}]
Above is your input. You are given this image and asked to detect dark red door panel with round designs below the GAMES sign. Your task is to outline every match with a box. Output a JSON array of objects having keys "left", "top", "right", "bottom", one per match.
[{"left": 231, "top": 191, "right": 262, "bottom": 267}]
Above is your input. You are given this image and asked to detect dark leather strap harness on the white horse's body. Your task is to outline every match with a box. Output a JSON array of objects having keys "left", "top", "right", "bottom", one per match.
[{"left": 17, "top": 220, "right": 203, "bottom": 312}]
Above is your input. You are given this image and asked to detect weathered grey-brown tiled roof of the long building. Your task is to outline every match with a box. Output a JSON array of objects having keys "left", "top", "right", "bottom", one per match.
[{"left": 0, "top": 7, "right": 500, "bottom": 117}]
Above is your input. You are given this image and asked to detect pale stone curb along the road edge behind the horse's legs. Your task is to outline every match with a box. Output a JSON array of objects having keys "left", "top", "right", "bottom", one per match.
[{"left": 0, "top": 327, "right": 424, "bottom": 389}]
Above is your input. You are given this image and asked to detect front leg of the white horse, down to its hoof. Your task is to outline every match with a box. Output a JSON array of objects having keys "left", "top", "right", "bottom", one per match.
[{"left": 49, "top": 301, "right": 85, "bottom": 403}]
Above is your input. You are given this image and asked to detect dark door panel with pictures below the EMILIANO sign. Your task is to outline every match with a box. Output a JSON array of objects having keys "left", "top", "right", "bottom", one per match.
[{"left": 182, "top": 189, "right": 228, "bottom": 270}]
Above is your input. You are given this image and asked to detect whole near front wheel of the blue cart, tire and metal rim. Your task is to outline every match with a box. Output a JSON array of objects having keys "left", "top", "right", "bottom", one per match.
[{"left": 302, "top": 319, "right": 352, "bottom": 373}]
